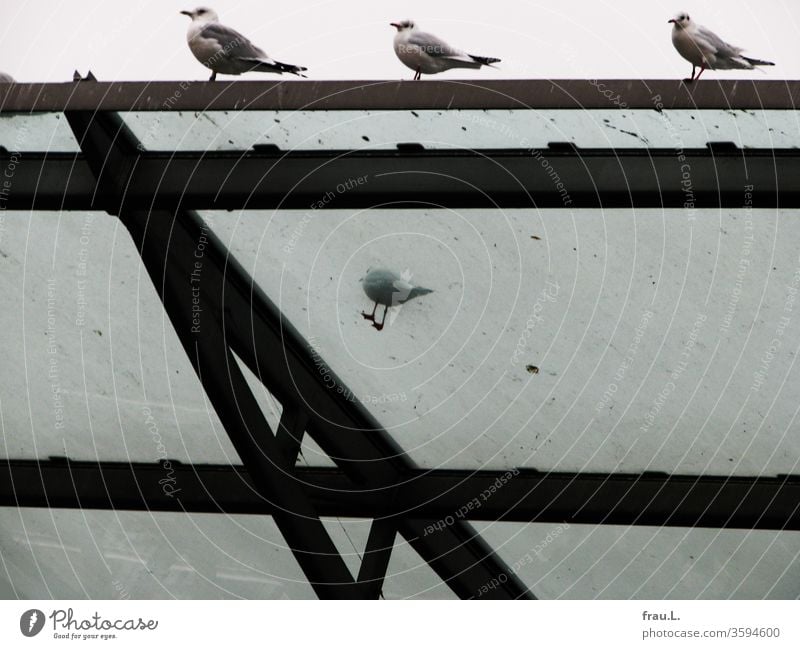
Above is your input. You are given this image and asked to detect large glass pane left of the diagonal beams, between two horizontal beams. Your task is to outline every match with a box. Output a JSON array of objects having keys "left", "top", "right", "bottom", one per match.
[{"left": 0, "top": 212, "right": 247, "bottom": 464}]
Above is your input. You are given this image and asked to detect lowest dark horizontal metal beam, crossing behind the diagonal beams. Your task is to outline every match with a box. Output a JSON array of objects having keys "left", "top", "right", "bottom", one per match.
[{"left": 6, "top": 459, "right": 800, "bottom": 528}]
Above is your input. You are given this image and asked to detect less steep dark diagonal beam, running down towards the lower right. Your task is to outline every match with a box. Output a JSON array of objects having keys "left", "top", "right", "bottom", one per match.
[{"left": 193, "top": 175, "right": 533, "bottom": 599}]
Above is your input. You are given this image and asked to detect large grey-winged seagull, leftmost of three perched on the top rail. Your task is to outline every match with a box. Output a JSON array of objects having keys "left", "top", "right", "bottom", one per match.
[{"left": 181, "top": 7, "right": 307, "bottom": 81}]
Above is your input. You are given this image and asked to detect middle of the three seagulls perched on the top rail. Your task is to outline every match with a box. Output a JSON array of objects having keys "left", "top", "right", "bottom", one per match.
[{"left": 389, "top": 20, "right": 500, "bottom": 81}]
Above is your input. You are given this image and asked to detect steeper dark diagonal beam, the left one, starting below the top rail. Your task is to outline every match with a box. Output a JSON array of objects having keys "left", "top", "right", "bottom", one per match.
[{"left": 66, "top": 106, "right": 365, "bottom": 599}]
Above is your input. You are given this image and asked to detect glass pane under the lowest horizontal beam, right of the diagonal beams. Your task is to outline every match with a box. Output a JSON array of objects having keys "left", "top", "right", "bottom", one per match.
[{"left": 475, "top": 523, "right": 800, "bottom": 600}]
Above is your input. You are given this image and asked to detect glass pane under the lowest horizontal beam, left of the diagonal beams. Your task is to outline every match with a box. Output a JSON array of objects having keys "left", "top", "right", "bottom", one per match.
[{"left": 0, "top": 507, "right": 314, "bottom": 599}]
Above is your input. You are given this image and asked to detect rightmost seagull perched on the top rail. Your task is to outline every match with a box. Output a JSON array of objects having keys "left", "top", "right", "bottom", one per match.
[{"left": 667, "top": 12, "right": 775, "bottom": 83}]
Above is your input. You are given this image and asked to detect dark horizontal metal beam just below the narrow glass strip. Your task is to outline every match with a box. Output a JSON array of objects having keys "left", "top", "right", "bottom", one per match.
[{"left": 0, "top": 144, "right": 800, "bottom": 210}]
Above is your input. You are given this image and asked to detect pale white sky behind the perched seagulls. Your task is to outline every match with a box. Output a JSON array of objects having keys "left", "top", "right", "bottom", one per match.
[{"left": 0, "top": 0, "right": 800, "bottom": 81}]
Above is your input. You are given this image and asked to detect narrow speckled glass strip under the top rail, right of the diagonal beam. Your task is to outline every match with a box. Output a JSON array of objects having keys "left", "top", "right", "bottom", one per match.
[{"left": 117, "top": 109, "right": 800, "bottom": 151}]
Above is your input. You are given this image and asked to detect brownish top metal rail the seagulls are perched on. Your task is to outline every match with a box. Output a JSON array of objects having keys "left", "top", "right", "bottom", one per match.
[{"left": 0, "top": 78, "right": 800, "bottom": 113}]
